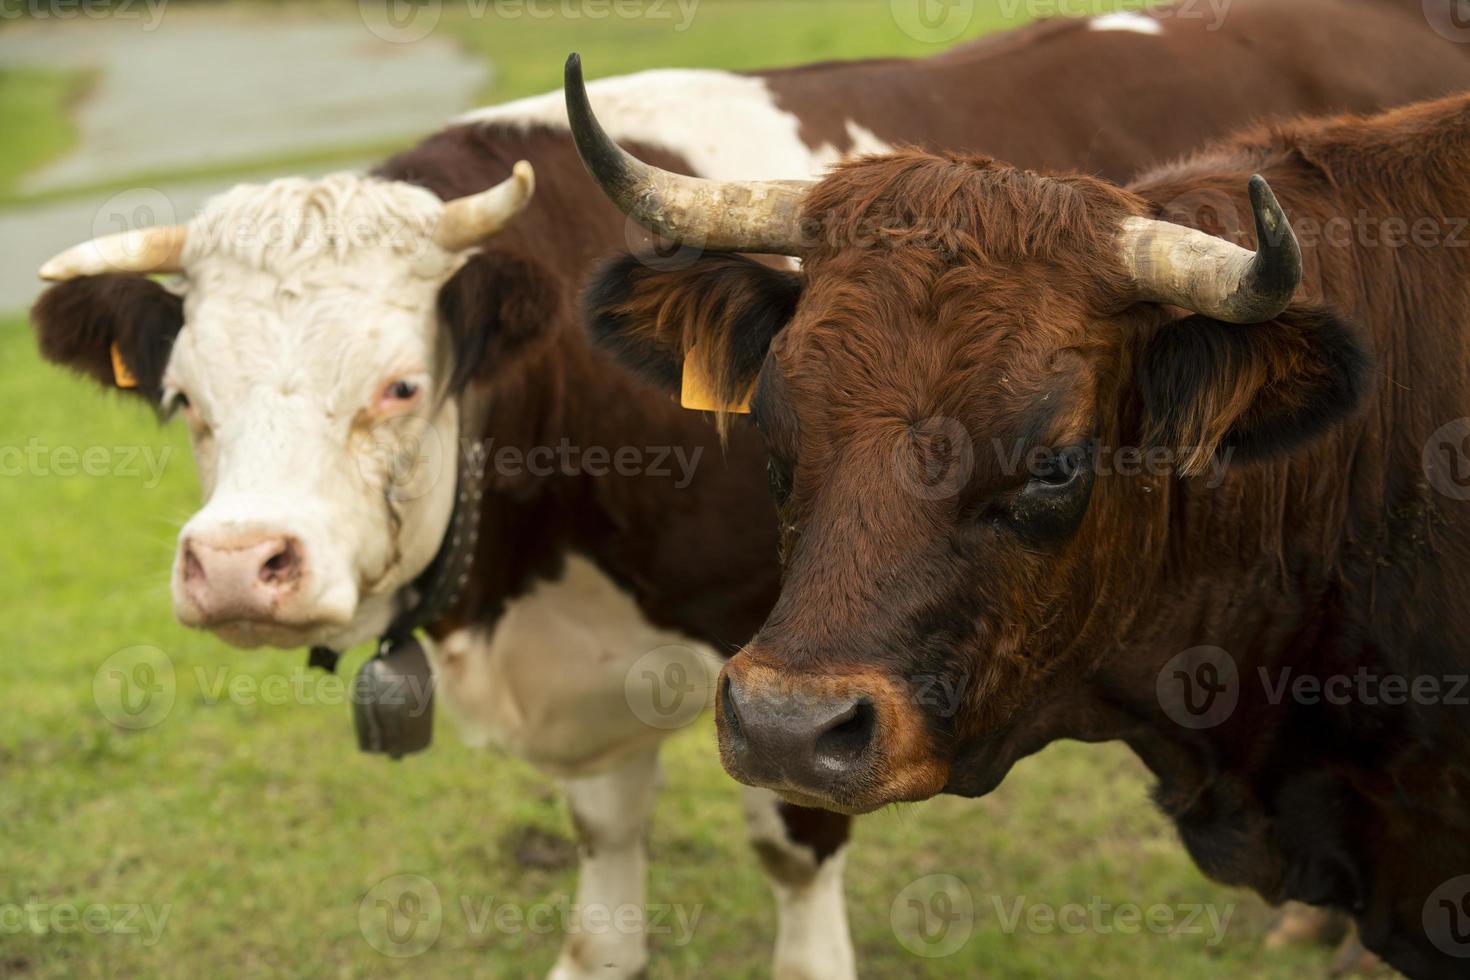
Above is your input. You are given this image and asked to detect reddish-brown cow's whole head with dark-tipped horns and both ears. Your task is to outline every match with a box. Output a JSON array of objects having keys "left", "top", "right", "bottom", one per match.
[{"left": 567, "top": 57, "right": 1367, "bottom": 811}]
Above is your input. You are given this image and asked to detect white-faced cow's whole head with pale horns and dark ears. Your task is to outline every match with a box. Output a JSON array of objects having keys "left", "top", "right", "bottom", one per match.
[{"left": 32, "top": 163, "right": 554, "bottom": 646}]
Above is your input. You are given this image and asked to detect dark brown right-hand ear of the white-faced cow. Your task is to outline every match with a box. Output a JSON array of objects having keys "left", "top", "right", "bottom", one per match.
[{"left": 438, "top": 251, "right": 562, "bottom": 392}]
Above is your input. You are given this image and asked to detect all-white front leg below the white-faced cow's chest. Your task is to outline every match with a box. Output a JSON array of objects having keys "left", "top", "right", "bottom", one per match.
[{"left": 551, "top": 749, "right": 659, "bottom": 980}]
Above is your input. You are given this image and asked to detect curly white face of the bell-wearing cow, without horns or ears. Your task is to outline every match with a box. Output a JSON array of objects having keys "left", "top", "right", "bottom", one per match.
[{"left": 163, "top": 173, "right": 463, "bottom": 646}]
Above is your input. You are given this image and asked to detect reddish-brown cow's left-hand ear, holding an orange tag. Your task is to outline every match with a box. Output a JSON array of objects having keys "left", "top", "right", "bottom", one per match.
[{"left": 582, "top": 256, "right": 801, "bottom": 404}]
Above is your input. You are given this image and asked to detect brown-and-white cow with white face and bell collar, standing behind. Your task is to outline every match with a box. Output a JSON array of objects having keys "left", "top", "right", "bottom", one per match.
[{"left": 34, "top": 0, "right": 1470, "bottom": 977}]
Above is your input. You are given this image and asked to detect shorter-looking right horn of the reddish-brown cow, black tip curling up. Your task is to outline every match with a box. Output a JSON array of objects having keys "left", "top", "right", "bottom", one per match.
[{"left": 1119, "top": 173, "right": 1301, "bottom": 323}]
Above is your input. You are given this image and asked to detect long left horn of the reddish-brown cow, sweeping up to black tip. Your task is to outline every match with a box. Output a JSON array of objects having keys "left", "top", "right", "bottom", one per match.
[{"left": 566, "top": 54, "right": 813, "bottom": 256}]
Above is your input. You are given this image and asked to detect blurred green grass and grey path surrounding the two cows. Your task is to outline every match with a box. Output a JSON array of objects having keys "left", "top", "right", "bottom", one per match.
[{"left": 0, "top": 0, "right": 1346, "bottom": 980}]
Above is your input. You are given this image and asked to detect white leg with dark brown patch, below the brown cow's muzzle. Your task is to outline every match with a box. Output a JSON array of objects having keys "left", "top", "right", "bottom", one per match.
[{"left": 742, "top": 786, "right": 857, "bottom": 980}]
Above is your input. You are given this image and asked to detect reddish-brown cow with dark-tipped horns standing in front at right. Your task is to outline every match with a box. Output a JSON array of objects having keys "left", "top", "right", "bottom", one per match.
[{"left": 567, "top": 72, "right": 1470, "bottom": 977}]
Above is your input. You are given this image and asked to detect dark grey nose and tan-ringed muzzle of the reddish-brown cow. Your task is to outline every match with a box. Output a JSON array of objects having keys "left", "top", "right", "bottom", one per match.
[{"left": 714, "top": 649, "right": 950, "bottom": 814}]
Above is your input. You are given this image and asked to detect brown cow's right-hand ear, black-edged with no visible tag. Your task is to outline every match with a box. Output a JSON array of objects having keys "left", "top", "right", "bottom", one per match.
[{"left": 1139, "top": 307, "right": 1372, "bottom": 475}]
